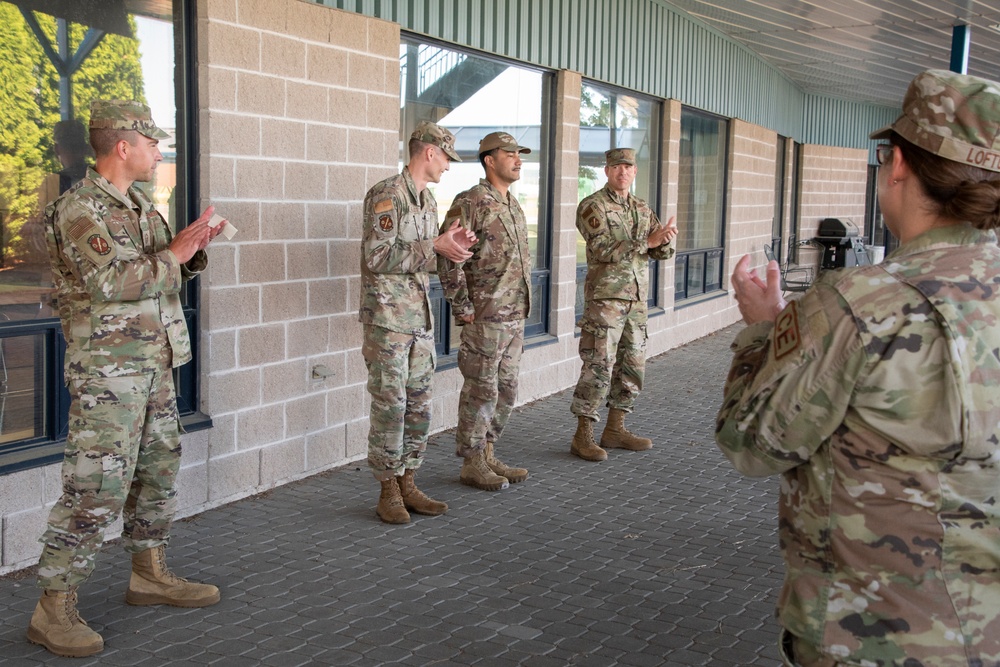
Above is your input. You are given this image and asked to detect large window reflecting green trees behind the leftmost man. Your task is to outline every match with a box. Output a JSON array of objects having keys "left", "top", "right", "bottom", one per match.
[{"left": 0, "top": 0, "right": 197, "bottom": 473}]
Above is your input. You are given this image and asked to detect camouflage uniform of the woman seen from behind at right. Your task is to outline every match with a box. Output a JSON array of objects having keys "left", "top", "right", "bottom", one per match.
[{"left": 717, "top": 225, "right": 1000, "bottom": 667}]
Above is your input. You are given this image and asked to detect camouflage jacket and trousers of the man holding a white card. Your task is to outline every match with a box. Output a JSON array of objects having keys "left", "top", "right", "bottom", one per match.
[{"left": 38, "top": 160, "right": 208, "bottom": 590}]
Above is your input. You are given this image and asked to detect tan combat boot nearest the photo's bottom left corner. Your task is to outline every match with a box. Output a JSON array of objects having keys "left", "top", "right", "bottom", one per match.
[{"left": 28, "top": 588, "right": 104, "bottom": 658}]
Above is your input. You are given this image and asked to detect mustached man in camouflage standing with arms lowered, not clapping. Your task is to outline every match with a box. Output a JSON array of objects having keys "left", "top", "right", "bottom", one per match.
[{"left": 438, "top": 132, "right": 531, "bottom": 491}]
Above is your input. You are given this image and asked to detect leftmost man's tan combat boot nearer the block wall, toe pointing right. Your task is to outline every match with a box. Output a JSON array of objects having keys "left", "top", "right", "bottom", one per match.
[{"left": 125, "top": 544, "right": 220, "bottom": 607}]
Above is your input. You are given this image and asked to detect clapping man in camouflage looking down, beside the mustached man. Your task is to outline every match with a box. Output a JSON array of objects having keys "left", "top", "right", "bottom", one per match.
[{"left": 359, "top": 121, "right": 476, "bottom": 523}]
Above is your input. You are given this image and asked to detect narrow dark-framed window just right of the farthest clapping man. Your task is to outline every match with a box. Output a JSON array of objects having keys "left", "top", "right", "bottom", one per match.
[{"left": 674, "top": 108, "right": 729, "bottom": 301}]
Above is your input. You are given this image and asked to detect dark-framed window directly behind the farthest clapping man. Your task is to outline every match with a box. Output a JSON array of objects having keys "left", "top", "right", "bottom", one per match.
[{"left": 576, "top": 82, "right": 660, "bottom": 319}]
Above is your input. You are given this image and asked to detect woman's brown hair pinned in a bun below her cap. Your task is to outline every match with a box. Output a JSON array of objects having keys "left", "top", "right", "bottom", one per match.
[{"left": 889, "top": 132, "right": 1000, "bottom": 229}]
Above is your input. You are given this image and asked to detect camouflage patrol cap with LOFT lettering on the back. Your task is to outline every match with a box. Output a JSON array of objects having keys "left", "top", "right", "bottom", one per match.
[{"left": 868, "top": 69, "right": 1000, "bottom": 172}]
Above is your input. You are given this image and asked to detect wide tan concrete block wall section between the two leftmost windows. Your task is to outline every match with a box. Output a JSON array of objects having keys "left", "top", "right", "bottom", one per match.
[{"left": 193, "top": 0, "right": 399, "bottom": 506}]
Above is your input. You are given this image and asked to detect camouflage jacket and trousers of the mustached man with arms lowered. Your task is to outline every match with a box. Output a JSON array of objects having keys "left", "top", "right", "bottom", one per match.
[{"left": 438, "top": 179, "right": 531, "bottom": 457}]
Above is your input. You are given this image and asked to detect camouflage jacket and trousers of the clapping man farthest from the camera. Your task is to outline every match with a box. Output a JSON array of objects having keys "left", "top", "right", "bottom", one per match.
[{"left": 571, "top": 186, "right": 674, "bottom": 421}]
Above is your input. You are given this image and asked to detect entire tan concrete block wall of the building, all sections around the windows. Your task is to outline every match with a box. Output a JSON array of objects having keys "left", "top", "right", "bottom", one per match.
[{"left": 0, "top": 0, "right": 868, "bottom": 572}]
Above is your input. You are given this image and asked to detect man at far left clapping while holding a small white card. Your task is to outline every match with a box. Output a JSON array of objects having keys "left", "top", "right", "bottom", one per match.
[{"left": 28, "top": 101, "right": 225, "bottom": 657}]
